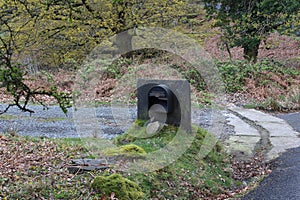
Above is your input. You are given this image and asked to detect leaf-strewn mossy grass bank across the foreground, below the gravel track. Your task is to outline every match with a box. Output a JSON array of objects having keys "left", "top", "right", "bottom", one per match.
[{"left": 0, "top": 121, "right": 237, "bottom": 199}]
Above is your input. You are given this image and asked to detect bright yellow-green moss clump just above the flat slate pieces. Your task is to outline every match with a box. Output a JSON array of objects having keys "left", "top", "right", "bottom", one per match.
[{"left": 104, "top": 144, "right": 146, "bottom": 157}]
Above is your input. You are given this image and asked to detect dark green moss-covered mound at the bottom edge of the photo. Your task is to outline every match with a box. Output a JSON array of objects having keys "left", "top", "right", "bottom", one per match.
[{"left": 91, "top": 174, "right": 145, "bottom": 200}]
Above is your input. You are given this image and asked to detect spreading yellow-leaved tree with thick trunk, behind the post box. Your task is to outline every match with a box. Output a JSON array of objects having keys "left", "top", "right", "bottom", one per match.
[{"left": 39, "top": 0, "right": 187, "bottom": 61}]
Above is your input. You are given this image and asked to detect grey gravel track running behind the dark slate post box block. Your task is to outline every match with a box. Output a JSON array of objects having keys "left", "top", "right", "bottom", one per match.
[{"left": 0, "top": 104, "right": 234, "bottom": 138}]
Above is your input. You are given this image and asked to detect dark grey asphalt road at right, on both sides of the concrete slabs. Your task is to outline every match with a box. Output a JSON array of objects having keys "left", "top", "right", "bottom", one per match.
[{"left": 243, "top": 113, "right": 300, "bottom": 200}]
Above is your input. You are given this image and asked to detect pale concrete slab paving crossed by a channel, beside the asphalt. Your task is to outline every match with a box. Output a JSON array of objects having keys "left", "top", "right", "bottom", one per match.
[{"left": 228, "top": 106, "right": 300, "bottom": 160}]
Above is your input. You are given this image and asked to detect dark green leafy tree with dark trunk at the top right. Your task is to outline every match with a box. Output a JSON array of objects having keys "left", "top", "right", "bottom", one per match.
[{"left": 203, "top": 0, "right": 300, "bottom": 62}]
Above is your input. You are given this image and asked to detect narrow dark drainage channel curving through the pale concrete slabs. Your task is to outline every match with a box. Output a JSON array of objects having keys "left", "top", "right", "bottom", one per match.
[{"left": 228, "top": 109, "right": 273, "bottom": 156}]
